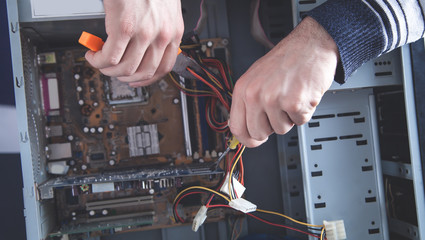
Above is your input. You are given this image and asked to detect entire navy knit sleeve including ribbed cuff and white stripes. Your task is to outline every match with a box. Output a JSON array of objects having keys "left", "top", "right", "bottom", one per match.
[{"left": 306, "top": 0, "right": 425, "bottom": 83}]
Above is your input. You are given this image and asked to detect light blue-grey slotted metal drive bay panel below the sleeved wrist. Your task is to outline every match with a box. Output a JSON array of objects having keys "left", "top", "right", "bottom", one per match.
[{"left": 299, "top": 89, "right": 388, "bottom": 239}]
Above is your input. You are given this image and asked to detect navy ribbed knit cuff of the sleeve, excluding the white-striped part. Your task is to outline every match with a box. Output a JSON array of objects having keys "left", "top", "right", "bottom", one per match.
[{"left": 306, "top": 0, "right": 386, "bottom": 83}]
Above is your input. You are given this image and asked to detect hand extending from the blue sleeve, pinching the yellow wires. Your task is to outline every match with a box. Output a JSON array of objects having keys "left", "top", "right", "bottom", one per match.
[{"left": 229, "top": 17, "right": 339, "bottom": 147}]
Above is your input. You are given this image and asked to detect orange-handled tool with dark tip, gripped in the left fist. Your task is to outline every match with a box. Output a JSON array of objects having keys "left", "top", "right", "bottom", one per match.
[{"left": 78, "top": 31, "right": 202, "bottom": 79}]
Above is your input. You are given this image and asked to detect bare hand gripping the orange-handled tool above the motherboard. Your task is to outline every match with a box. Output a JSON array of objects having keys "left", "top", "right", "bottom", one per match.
[{"left": 86, "top": 0, "right": 184, "bottom": 87}]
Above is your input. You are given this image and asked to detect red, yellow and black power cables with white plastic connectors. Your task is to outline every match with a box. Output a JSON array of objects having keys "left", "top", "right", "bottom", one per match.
[{"left": 170, "top": 37, "right": 325, "bottom": 239}]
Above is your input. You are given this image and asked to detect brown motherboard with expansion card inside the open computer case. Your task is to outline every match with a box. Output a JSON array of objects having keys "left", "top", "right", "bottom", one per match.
[{"left": 37, "top": 39, "right": 234, "bottom": 239}]
